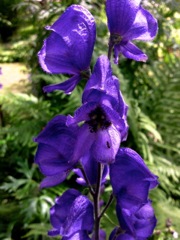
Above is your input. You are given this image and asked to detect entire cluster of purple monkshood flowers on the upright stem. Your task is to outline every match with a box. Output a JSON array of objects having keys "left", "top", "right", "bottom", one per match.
[{"left": 35, "top": 0, "right": 158, "bottom": 240}]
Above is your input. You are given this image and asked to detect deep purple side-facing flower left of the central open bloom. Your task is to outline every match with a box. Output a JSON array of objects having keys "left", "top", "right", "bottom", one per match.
[{"left": 35, "top": 115, "right": 79, "bottom": 188}]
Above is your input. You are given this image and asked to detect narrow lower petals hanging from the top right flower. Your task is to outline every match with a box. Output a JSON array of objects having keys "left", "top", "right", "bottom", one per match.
[{"left": 114, "top": 42, "right": 148, "bottom": 63}]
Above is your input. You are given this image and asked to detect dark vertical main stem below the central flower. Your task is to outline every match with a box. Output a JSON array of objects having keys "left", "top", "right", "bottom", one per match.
[{"left": 94, "top": 163, "right": 104, "bottom": 240}]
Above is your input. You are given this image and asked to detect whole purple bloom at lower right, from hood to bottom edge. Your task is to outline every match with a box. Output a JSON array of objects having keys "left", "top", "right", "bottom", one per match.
[{"left": 110, "top": 148, "right": 158, "bottom": 240}]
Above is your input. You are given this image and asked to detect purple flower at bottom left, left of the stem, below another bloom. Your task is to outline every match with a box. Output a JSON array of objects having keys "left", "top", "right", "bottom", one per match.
[{"left": 48, "top": 189, "right": 94, "bottom": 240}]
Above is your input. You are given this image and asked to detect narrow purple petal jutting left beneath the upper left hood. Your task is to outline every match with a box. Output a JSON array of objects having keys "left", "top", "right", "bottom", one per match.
[{"left": 43, "top": 75, "right": 81, "bottom": 94}]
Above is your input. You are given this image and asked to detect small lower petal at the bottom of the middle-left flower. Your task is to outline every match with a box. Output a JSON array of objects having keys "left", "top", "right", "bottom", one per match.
[{"left": 40, "top": 172, "right": 67, "bottom": 188}]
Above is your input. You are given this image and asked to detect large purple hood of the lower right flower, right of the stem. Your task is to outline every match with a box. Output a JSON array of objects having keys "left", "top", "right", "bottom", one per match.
[{"left": 110, "top": 148, "right": 158, "bottom": 204}]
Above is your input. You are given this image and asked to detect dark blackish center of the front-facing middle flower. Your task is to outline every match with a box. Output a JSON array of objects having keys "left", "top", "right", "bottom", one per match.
[{"left": 86, "top": 107, "right": 111, "bottom": 133}]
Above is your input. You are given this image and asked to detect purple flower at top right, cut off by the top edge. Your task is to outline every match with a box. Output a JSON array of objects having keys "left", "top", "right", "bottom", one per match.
[{"left": 106, "top": 0, "right": 158, "bottom": 64}]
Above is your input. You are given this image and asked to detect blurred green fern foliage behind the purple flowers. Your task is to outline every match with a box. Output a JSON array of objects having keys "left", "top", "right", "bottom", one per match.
[{"left": 0, "top": 0, "right": 180, "bottom": 240}]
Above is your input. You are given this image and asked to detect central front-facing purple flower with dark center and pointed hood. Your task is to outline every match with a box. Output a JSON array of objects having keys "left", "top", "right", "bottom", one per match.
[{"left": 67, "top": 56, "right": 128, "bottom": 164}]
